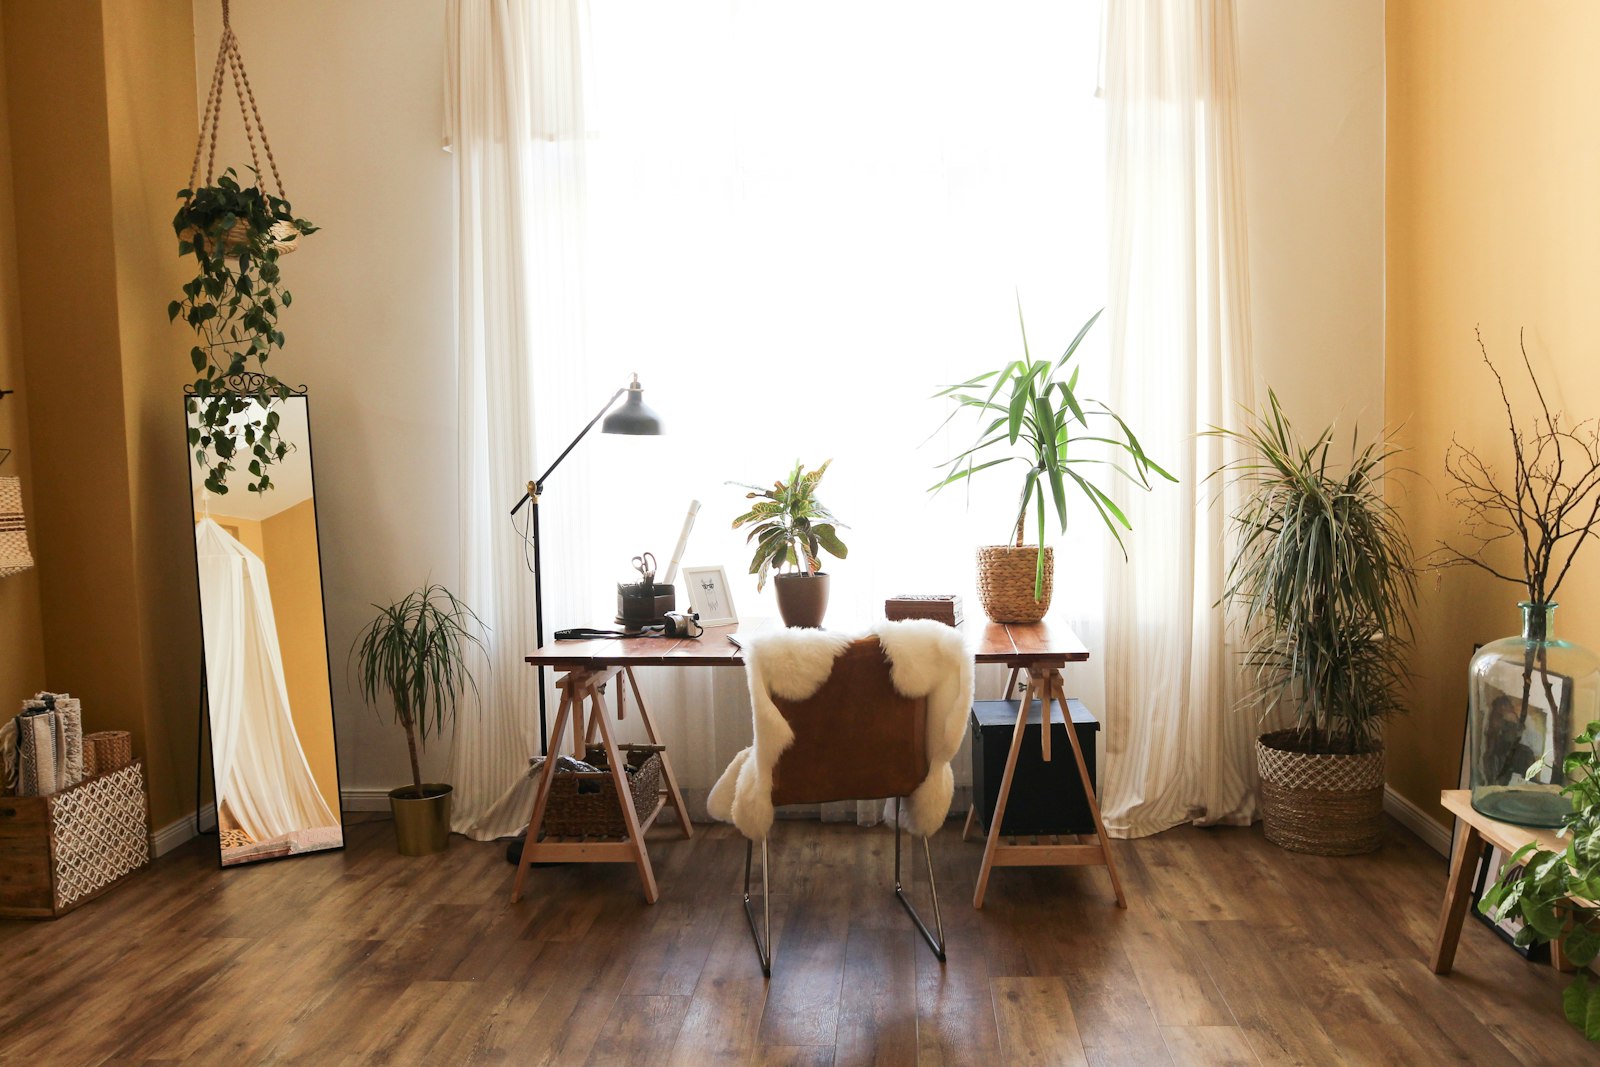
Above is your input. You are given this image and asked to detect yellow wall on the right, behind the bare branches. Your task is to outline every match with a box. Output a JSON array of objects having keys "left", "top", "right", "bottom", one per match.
[{"left": 1386, "top": 0, "right": 1600, "bottom": 822}]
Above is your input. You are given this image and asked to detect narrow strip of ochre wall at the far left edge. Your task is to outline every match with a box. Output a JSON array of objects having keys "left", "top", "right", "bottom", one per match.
[{"left": 0, "top": 16, "right": 45, "bottom": 703}]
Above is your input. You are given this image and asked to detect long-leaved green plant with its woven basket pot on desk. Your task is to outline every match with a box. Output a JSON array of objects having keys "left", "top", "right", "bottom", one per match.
[{"left": 928, "top": 306, "right": 1178, "bottom": 622}]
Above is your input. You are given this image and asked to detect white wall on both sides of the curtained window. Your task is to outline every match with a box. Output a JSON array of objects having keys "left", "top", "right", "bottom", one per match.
[{"left": 195, "top": 0, "right": 1384, "bottom": 792}]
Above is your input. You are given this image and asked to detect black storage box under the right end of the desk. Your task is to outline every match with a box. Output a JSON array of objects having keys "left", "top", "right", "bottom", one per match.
[{"left": 970, "top": 697, "right": 1099, "bottom": 837}]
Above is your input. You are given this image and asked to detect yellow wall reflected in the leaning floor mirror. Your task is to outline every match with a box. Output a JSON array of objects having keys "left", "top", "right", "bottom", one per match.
[{"left": 261, "top": 501, "right": 339, "bottom": 811}]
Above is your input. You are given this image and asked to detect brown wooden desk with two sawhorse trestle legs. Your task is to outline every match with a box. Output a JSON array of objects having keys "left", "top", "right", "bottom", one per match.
[{"left": 512, "top": 619, "right": 1126, "bottom": 907}]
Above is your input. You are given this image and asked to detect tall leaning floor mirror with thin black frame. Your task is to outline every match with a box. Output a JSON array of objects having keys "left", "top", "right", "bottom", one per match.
[{"left": 184, "top": 388, "right": 344, "bottom": 867}]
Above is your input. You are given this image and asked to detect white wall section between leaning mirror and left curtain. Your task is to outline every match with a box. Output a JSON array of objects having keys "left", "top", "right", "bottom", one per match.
[{"left": 193, "top": 0, "right": 458, "bottom": 792}]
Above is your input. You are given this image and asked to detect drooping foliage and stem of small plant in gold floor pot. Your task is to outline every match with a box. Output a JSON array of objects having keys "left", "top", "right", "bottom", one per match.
[{"left": 354, "top": 584, "right": 485, "bottom": 797}]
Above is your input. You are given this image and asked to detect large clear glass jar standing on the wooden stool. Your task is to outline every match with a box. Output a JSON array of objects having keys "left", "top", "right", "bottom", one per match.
[{"left": 1467, "top": 601, "right": 1600, "bottom": 827}]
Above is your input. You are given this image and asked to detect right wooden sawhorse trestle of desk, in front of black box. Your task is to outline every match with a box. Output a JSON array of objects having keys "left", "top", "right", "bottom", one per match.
[{"left": 962, "top": 667, "right": 1128, "bottom": 907}]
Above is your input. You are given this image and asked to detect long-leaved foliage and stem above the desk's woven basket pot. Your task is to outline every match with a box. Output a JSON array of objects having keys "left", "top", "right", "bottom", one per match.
[{"left": 928, "top": 304, "right": 1178, "bottom": 598}]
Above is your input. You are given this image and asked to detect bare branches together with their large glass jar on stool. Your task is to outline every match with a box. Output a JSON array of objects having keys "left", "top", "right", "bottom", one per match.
[{"left": 1440, "top": 329, "right": 1600, "bottom": 827}]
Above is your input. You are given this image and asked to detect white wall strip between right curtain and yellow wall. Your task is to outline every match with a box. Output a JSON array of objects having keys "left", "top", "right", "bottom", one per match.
[{"left": 1237, "top": 0, "right": 1384, "bottom": 435}]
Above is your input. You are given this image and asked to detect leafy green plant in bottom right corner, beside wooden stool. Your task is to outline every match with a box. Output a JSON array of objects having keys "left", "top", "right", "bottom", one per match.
[{"left": 1478, "top": 721, "right": 1600, "bottom": 1041}]
